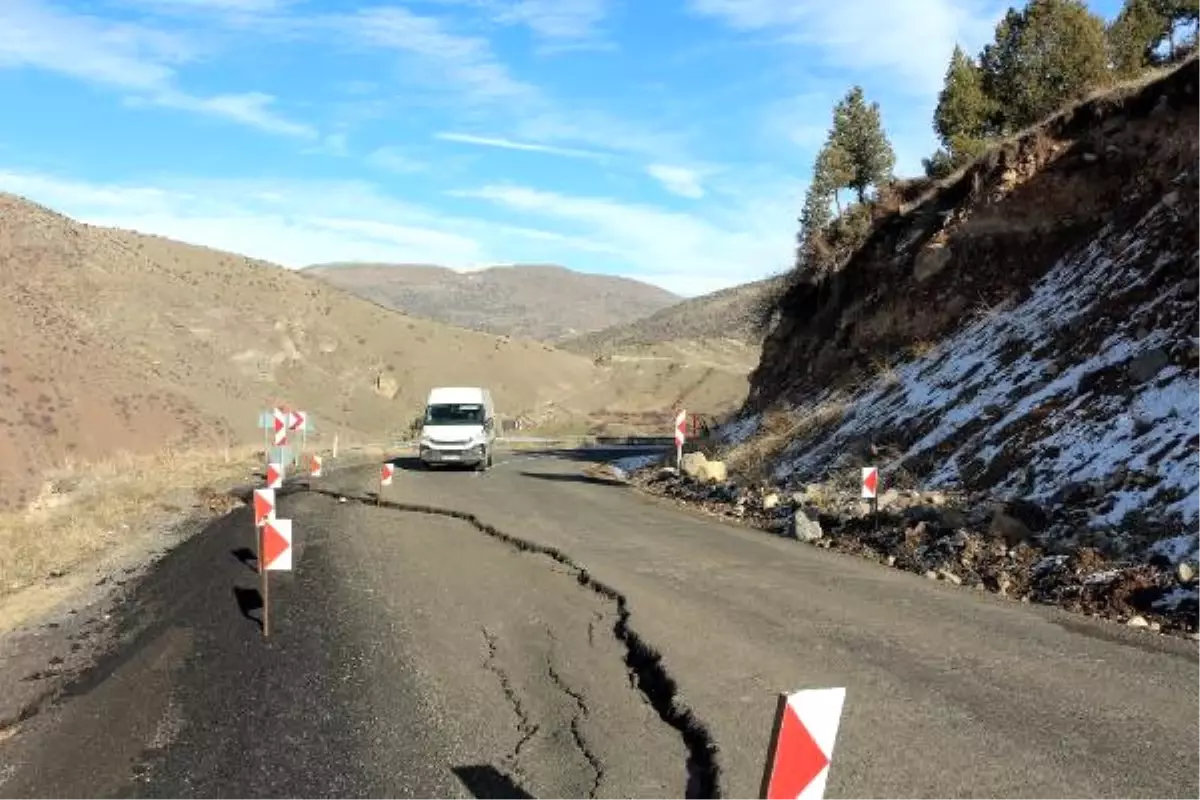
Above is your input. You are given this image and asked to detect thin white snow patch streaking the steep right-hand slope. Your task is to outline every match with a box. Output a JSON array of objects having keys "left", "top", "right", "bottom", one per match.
[{"left": 768, "top": 191, "right": 1200, "bottom": 537}]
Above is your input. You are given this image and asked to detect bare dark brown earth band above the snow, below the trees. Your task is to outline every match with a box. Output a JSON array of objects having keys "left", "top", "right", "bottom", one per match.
[{"left": 750, "top": 59, "right": 1200, "bottom": 409}]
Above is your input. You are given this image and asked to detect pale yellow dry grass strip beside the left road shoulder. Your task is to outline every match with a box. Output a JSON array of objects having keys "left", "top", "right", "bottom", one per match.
[{"left": 0, "top": 447, "right": 260, "bottom": 596}]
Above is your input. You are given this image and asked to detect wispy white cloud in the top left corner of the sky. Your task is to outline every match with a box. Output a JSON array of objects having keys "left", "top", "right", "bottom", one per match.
[{"left": 0, "top": 0, "right": 316, "bottom": 138}]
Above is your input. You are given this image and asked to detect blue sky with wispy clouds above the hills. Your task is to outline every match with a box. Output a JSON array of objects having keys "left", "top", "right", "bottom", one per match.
[{"left": 0, "top": 0, "right": 1118, "bottom": 295}]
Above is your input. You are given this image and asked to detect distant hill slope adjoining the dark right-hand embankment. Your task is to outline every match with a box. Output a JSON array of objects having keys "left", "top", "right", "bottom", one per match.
[{"left": 558, "top": 277, "right": 784, "bottom": 356}]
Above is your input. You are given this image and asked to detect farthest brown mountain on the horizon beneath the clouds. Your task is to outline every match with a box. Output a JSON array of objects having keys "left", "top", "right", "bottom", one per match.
[{"left": 302, "top": 264, "right": 679, "bottom": 341}]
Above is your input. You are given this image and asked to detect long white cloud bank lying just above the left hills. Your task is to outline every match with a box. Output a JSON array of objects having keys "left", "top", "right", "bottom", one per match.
[{"left": 0, "top": 168, "right": 628, "bottom": 269}]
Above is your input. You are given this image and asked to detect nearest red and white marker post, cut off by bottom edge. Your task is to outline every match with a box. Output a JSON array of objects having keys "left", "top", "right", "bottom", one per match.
[{"left": 758, "top": 688, "right": 846, "bottom": 800}]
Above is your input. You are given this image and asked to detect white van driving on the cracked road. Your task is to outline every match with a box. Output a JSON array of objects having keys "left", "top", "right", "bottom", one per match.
[{"left": 420, "top": 386, "right": 496, "bottom": 470}]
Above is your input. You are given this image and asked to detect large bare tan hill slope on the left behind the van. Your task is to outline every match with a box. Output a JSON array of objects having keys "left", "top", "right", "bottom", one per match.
[{"left": 0, "top": 194, "right": 598, "bottom": 504}]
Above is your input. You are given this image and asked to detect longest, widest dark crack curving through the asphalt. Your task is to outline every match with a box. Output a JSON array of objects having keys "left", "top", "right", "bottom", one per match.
[{"left": 309, "top": 486, "right": 721, "bottom": 800}]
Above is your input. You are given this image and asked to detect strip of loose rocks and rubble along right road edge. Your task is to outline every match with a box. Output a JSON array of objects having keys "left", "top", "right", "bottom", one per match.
[{"left": 626, "top": 453, "right": 1200, "bottom": 640}]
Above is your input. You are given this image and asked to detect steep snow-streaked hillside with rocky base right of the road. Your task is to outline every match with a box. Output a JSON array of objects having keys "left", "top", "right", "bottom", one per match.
[{"left": 628, "top": 54, "right": 1200, "bottom": 636}]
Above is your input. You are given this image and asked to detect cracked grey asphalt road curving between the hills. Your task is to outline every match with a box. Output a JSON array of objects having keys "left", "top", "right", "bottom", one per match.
[{"left": 0, "top": 453, "right": 1200, "bottom": 800}]
